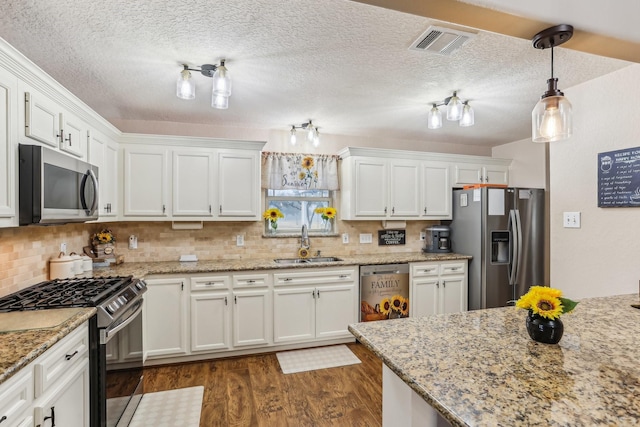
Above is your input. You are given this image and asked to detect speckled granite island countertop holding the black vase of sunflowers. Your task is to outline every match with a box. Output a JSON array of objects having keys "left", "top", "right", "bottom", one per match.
[{"left": 349, "top": 294, "right": 640, "bottom": 426}]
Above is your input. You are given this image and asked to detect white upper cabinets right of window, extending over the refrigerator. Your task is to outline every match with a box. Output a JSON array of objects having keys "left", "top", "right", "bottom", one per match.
[{"left": 338, "top": 147, "right": 511, "bottom": 220}]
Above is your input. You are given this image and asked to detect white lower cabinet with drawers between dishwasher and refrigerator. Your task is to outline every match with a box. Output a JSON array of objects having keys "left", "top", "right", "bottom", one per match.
[{"left": 409, "top": 260, "right": 468, "bottom": 317}]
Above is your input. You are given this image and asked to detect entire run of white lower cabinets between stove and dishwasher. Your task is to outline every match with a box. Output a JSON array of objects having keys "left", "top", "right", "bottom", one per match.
[{"left": 142, "top": 266, "right": 358, "bottom": 360}]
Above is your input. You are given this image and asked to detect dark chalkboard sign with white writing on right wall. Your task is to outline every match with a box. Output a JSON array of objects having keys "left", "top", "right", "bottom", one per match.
[{"left": 598, "top": 147, "right": 640, "bottom": 208}]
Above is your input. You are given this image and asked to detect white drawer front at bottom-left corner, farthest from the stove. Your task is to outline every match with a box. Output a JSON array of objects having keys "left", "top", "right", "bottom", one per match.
[{"left": 0, "top": 365, "right": 33, "bottom": 426}]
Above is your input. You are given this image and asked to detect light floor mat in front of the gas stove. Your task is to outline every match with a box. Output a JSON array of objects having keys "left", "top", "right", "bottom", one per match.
[{"left": 129, "top": 386, "right": 204, "bottom": 427}]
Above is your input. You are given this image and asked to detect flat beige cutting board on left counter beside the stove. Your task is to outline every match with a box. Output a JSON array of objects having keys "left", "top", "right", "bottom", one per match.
[{"left": 0, "top": 307, "right": 83, "bottom": 333}]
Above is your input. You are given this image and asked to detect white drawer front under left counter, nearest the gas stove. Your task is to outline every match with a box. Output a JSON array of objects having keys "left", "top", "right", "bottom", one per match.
[{"left": 34, "top": 323, "right": 89, "bottom": 397}]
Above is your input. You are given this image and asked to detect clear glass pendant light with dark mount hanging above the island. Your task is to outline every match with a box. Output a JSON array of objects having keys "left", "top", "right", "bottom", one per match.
[{"left": 531, "top": 24, "right": 573, "bottom": 142}]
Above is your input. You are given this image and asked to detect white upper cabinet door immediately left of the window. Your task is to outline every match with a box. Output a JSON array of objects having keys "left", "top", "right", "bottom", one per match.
[{"left": 216, "top": 150, "right": 260, "bottom": 220}]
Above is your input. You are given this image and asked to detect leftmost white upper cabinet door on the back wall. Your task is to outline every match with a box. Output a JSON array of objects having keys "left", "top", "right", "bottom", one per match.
[{"left": 123, "top": 146, "right": 170, "bottom": 219}]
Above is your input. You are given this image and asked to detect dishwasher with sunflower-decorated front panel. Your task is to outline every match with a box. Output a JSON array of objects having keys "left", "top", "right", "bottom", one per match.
[{"left": 360, "top": 264, "right": 409, "bottom": 322}]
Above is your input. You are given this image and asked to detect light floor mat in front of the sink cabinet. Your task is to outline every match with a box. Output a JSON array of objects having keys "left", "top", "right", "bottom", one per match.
[{"left": 276, "top": 345, "right": 361, "bottom": 374}]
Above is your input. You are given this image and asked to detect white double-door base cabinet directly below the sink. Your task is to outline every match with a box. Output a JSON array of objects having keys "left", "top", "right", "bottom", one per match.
[{"left": 273, "top": 267, "right": 358, "bottom": 343}]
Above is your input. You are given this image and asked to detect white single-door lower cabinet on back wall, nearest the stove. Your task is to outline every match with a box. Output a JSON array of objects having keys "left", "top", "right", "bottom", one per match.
[{"left": 143, "top": 276, "right": 189, "bottom": 358}]
